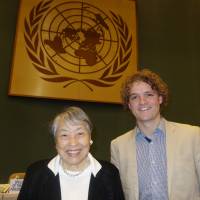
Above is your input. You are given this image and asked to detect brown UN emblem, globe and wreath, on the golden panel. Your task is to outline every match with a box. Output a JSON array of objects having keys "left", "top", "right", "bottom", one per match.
[{"left": 24, "top": 0, "right": 132, "bottom": 91}]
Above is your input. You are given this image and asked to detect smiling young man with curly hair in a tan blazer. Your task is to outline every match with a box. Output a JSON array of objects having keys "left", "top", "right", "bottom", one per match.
[{"left": 111, "top": 69, "right": 200, "bottom": 200}]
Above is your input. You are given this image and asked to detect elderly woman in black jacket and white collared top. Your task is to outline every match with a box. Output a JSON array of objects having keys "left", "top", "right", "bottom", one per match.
[{"left": 18, "top": 107, "right": 124, "bottom": 200}]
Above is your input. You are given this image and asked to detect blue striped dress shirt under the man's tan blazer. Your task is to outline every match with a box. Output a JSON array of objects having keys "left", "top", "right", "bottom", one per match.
[{"left": 136, "top": 124, "right": 168, "bottom": 200}]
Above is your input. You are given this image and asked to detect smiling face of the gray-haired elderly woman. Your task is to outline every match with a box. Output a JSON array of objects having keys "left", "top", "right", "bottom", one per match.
[{"left": 55, "top": 120, "right": 91, "bottom": 170}]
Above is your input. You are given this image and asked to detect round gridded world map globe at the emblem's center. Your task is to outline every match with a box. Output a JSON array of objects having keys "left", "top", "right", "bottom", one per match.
[{"left": 40, "top": 1, "right": 119, "bottom": 74}]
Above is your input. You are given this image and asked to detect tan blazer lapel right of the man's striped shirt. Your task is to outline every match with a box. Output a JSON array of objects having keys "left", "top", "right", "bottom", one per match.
[{"left": 165, "top": 120, "right": 176, "bottom": 197}]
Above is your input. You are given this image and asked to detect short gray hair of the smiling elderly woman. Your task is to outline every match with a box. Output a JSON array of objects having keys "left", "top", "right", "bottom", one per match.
[{"left": 51, "top": 106, "right": 93, "bottom": 137}]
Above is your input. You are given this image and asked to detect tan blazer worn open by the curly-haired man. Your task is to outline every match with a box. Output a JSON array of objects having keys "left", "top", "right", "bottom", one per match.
[{"left": 111, "top": 120, "right": 200, "bottom": 200}]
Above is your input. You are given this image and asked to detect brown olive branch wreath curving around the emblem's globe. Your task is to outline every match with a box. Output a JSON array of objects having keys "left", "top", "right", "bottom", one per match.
[{"left": 24, "top": 0, "right": 132, "bottom": 91}]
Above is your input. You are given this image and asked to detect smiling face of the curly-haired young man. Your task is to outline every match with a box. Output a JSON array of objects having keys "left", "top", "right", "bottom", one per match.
[{"left": 128, "top": 81, "right": 162, "bottom": 123}]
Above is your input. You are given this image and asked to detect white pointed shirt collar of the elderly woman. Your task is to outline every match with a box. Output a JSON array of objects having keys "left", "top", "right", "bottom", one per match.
[{"left": 47, "top": 153, "right": 102, "bottom": 176}]
